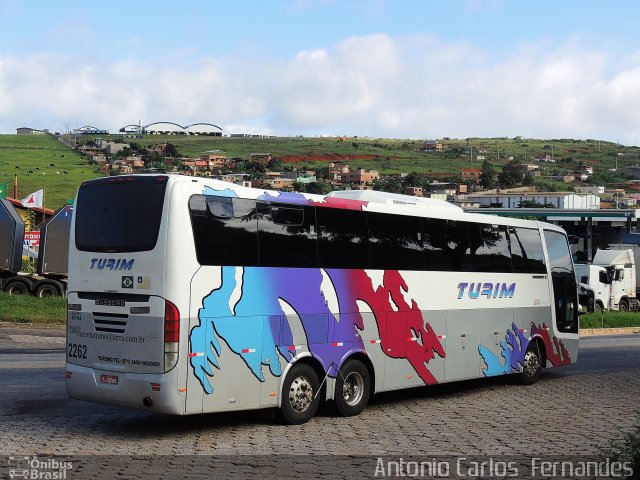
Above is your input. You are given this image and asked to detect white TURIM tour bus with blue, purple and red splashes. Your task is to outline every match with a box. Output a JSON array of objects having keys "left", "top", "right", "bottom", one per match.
[{"left": 65, "top": 175, "right": 593, "bottom": 423}]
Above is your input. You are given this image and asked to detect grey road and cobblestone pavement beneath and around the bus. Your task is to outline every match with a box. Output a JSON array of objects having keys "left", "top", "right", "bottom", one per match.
[{"left": 0, "top": 329, "right": 640, "bottom": 479}]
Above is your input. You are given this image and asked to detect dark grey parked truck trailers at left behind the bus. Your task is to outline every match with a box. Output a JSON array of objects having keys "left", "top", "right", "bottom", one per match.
[{"left": 0, "top": 199, "right": 73, "bottom": 297}]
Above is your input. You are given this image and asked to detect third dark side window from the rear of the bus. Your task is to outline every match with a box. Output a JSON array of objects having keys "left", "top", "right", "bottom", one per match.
[{"left": 316, "top": 207, "right": 369, "bottom": 268}]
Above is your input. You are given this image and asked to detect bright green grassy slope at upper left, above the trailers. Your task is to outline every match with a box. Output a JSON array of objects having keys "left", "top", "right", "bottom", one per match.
[{"left": 0, "top": 135, "right": 101, "bottom": 210}]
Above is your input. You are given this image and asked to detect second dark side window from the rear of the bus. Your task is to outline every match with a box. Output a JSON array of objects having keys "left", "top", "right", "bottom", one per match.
[{"left": 258, "top": 202, "right": 317, "bottom": 267}]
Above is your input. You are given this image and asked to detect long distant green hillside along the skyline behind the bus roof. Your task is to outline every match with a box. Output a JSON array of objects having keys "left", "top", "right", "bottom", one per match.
[{"left": 87, "top": 135, "right": 640, "bottom": 175}]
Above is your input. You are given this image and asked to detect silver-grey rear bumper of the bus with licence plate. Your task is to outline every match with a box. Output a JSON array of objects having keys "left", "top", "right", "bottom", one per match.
[{"left": 65, "top": 363, "right": 185, "bottom": 415}]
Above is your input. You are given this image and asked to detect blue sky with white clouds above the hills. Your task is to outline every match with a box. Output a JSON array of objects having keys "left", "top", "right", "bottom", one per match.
[{"left": 0, "top": 0, "right": 640, "bottom": 145}]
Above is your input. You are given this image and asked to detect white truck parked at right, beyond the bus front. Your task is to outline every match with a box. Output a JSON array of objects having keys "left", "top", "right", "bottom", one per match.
[{"left": 575, "top": 249, "right": 640, "bottom": 311}]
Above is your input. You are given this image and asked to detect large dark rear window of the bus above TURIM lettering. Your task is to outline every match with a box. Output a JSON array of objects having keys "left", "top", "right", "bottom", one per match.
[{"left": 75, "top": 176, "right": 167, "bottom": 252}]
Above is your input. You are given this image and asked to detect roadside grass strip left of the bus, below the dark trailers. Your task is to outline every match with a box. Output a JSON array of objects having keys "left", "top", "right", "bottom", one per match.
[{"left": 0, "top": 292, "right": 67, "bottom": 324}]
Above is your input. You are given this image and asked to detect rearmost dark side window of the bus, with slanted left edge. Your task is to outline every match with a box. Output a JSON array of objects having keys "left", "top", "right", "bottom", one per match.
[{"left": 189, "top": 195, "right": 258, "bottom": 266}]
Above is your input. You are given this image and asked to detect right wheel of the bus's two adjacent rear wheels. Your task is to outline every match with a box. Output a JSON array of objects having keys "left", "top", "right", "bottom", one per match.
[{"left": 334, "top": 359, "right": 371, "bottom": 417}]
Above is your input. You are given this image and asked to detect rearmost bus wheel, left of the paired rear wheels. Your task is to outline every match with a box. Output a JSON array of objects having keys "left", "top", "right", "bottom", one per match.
[{"left": 278, "top": 363, "right": 320, "bottom": 425}]
